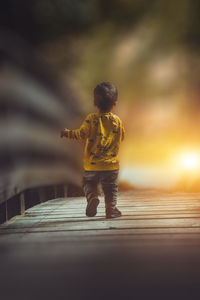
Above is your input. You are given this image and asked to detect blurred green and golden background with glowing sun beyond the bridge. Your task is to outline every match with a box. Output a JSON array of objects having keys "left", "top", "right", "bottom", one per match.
[{"left": 0, "top": 0, "right": 200, "bottom": 192}]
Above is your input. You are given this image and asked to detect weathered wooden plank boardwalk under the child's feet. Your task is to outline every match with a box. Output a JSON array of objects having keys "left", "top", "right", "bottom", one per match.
[{"left": 0, "top": 191, "right": 200, "bottom": 300}]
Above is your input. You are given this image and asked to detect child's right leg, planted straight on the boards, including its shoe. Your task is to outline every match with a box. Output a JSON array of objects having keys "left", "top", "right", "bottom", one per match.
[{"left": 101, "top": 170, "right": 121, "bottom": 217}]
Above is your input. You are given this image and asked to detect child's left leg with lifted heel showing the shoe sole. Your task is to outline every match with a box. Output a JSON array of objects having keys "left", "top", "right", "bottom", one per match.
[{"left": 83, "top": 171, "right": 99, "bottom": 217}]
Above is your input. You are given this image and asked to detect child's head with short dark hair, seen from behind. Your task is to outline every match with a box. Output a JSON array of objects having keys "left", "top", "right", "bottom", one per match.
[{"left": 94, "top": 82, "right": 118, "bottom": 113}]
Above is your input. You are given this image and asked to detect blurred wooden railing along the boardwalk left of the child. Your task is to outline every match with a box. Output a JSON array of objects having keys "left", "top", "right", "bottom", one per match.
[{"left": 0, "top": 34, "right": 81, "bottom": 223}]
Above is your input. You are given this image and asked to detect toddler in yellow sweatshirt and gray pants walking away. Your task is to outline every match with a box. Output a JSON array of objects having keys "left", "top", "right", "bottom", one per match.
[{"left": 61, "top": 82, "right": 124, "bottom": 218}]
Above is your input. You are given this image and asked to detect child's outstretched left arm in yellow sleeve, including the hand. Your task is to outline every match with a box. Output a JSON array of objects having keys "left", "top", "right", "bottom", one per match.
[{"left": 60, "top": 115, "right": 91, "bottom": 141}]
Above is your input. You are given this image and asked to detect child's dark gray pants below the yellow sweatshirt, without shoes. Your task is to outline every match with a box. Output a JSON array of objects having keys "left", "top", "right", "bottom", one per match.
[{"left": 83, "top": 170, "right": 119, "bottom": 209}]
